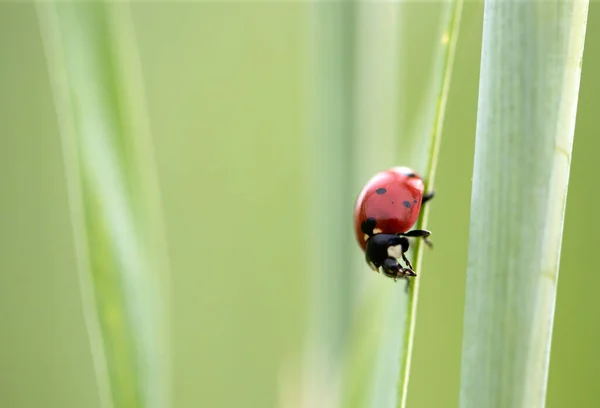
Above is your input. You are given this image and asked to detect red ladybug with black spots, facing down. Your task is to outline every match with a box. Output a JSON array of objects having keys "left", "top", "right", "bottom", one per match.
[{"left": 354, "top": 167, "right": 433, "bottom": 280}]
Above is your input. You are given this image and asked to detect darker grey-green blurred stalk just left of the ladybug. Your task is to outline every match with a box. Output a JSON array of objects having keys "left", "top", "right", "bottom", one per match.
[{"left": 303, "top": 1, "right": 355, "bottom": 408}]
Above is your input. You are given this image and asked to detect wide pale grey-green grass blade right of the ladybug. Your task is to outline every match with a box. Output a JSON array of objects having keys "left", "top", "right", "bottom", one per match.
[{"left": 460, "top": 0, "right": 588, "bottom": 408}]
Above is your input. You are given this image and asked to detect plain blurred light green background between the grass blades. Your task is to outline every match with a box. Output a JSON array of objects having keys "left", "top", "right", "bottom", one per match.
[{"left": 0, "top": 2, "right": 600, "bottom": 408}]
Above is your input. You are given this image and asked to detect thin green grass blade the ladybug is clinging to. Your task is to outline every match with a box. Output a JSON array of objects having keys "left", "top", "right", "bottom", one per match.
[{"left": 397, "top": 0, "right": 463, "bottom": 408}]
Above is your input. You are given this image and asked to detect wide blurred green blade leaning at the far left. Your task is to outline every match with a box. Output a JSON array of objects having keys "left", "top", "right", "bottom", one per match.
[{"left": 37, "top": 2, "right": 170, "bottom": 408}]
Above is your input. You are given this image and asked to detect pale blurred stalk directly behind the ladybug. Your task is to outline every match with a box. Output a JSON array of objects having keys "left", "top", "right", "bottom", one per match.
[{"left": 343, "top": 0, "right": 405, "bottom": 408}]
